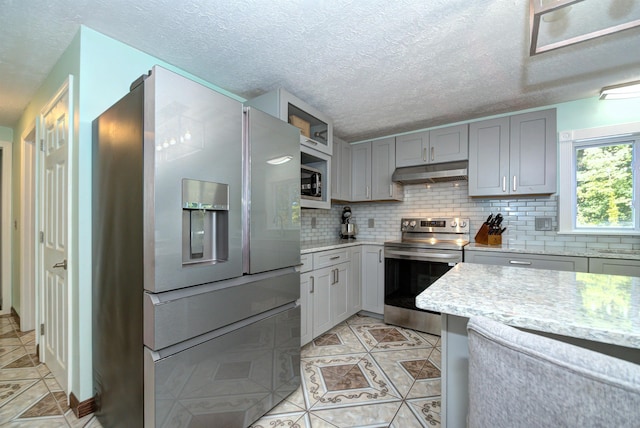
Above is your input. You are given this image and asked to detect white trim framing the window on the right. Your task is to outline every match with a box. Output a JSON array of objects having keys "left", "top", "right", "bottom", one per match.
[{"left": 558, "top": 122, "right": 640, "bottom": 236}]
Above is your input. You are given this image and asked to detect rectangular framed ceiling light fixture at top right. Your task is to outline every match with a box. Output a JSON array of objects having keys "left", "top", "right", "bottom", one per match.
[{"left": 529, "top": 0, "right": 640, "bottom": 56}]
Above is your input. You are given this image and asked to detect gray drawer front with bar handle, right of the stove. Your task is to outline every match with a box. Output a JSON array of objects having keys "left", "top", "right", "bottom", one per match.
[{"left": 464, "top": 251, "right": 589, "bottom": 272}]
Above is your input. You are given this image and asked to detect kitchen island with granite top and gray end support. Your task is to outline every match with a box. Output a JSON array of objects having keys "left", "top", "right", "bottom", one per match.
[{"left": 416, "top": 263, "right": 640, "bottom": 427}]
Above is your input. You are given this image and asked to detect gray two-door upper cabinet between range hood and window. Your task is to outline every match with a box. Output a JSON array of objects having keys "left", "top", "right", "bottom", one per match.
[{"left": 469, "top": 109, "right": 557, "bottom": 196}]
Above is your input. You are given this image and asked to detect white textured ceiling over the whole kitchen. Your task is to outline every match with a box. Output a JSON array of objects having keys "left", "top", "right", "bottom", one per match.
[{"left": 0, "top": 0, "right": 640, "bottom": 141}]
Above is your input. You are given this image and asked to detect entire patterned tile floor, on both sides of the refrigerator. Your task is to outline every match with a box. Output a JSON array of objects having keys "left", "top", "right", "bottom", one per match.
[{"left": 0, "top": 315, "right": 440, "bottom": 428}]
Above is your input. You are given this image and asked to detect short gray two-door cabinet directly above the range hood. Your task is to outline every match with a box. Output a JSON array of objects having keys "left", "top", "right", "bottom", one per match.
[{"left": 396, "top": 124, "right": 469, "bottom": 167}]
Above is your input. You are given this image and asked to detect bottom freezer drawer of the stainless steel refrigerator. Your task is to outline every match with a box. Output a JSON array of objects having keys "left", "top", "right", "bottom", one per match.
[{"left": 144, "top": 306, "right": 300, "bottom": 428}]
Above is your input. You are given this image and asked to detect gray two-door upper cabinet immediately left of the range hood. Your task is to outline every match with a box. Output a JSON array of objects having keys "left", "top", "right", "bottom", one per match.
[{"left": 351, "top": 137, "right": 404, "bottom": 202}]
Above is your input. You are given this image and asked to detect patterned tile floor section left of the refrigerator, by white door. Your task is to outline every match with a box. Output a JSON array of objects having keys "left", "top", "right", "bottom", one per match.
[{"left": 0, "top": 316, "right": 100, "bottom": 428}]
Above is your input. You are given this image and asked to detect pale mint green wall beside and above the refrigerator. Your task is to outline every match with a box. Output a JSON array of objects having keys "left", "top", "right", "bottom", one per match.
[{"left": 72, "top": 27, "right": 244, "bottom": 400}]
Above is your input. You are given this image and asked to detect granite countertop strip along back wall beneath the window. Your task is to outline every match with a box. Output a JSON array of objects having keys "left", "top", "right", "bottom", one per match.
[{"left": 464, "top": 243, "right": 640, "bottom": 260}]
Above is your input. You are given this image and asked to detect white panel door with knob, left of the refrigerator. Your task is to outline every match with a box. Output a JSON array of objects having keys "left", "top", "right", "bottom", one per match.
[{"left": 41, "top": 79, "right": 70, "bottom": 392}]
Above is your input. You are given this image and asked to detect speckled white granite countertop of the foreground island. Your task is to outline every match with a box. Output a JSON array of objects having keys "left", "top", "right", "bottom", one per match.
[{"left": 416, "top": 263, "right": 640, "bottom": 349}]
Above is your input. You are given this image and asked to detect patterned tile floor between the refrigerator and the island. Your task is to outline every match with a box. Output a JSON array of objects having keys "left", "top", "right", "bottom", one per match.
[{"left": 252, "top": 315, "right": 441, "bottom": 428}]
